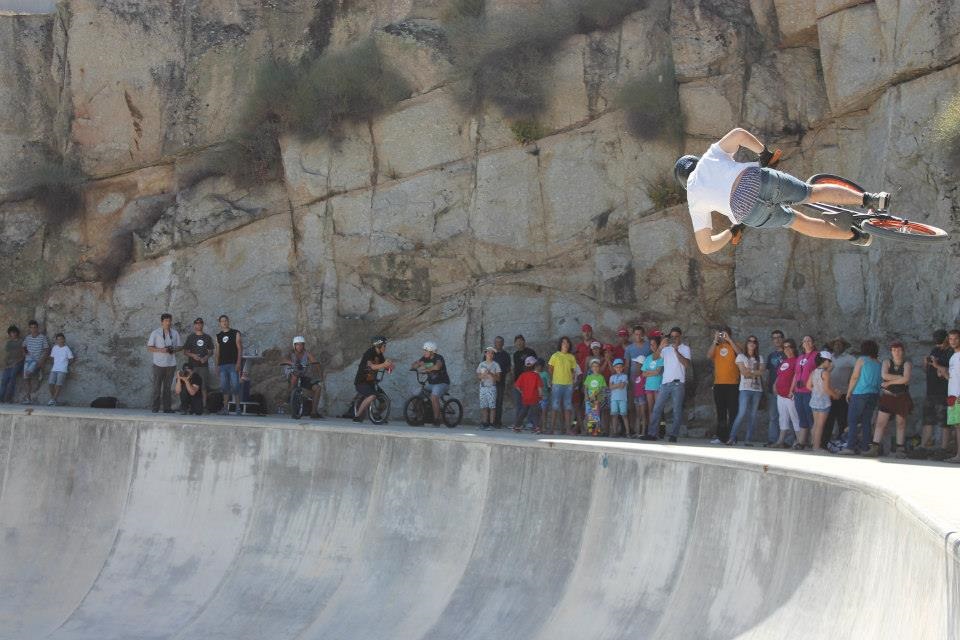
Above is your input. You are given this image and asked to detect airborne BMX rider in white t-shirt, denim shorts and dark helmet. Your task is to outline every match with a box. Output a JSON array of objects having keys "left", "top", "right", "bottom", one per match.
[{"left": 673, "top": 128, "right": 890, "bottom": 253}]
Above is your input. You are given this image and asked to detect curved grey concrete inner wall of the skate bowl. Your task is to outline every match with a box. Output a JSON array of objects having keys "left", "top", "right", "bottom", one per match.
[{"left": 0, "top": 412, "right": 958, "bottom": 640}]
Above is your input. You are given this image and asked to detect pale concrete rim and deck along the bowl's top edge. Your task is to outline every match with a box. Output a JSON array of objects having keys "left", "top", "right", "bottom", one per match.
[{"left": 0, "top": 405, "right": 960, "bottom": 559}]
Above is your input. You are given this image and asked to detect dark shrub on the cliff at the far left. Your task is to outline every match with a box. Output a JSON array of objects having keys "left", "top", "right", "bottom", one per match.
[{"left": 17, "top": 153, "right": 87, "bottom": 226}]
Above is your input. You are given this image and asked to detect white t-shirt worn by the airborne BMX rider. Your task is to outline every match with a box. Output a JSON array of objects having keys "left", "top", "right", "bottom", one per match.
[{"left": 687, "top": 142, "right": 760, "bottom": 232}]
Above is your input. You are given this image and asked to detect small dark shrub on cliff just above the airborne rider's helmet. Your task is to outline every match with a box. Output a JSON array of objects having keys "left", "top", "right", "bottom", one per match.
[{"left": 614, "top": 65, "right": 683, "bottom": 142}]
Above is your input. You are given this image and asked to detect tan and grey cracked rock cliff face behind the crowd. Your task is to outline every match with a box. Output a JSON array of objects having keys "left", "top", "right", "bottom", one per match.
[{"left": 0, "top": 0, "right": 960, "bottom": 422}]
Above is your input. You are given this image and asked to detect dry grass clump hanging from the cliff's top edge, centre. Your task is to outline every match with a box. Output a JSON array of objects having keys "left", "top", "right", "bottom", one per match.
[{"left": 446, "top": 0, "right": 646, "bottom": 120}]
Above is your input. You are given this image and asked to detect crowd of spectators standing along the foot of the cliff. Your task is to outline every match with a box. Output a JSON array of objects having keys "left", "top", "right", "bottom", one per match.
[{"left": 0, "top": 313, "right": 960, "bottom": 462}]
